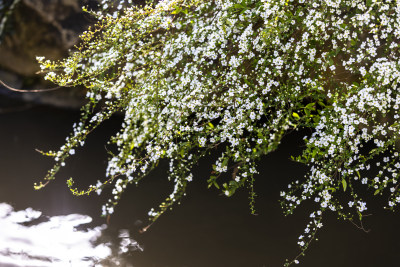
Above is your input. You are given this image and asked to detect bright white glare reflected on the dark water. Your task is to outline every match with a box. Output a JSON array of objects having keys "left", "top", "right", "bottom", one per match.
[{"left": 0, "top": 203, "right": 143, "bottom": 267}]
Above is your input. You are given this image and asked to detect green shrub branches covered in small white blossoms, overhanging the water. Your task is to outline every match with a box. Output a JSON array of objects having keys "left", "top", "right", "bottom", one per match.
[{"left": 36, "top": 0, "right": 400, "bottom": 265}]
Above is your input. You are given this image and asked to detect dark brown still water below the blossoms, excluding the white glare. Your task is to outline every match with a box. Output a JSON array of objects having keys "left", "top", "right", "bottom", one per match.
[{"left": 0, "top": 103, "right": 400, "bottom": 267}]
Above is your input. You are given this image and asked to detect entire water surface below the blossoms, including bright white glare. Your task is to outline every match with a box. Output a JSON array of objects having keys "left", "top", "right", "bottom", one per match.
[{"left": 0, "top": 101, "right": 400, "bottom": 267}]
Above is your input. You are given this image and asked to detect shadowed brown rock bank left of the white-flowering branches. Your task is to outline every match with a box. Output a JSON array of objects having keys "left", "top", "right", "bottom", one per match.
[{"left": 0, "top": 0, "right": 96, "bottom": 108}]
